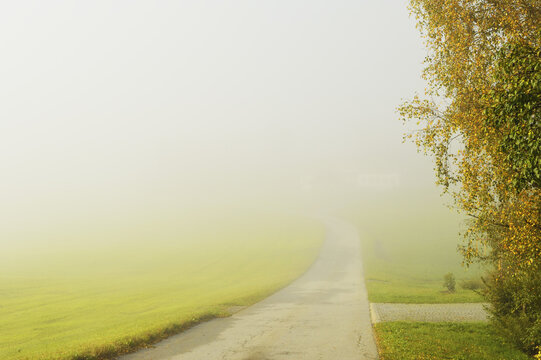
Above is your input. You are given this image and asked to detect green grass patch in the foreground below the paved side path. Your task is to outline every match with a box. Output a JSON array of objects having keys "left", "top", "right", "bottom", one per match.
[{"left": 375, "top": 322, "right": 530, "bottom": 360}]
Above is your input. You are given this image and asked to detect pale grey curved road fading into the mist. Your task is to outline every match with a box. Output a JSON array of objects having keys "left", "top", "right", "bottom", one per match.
[{"left": 120, "top": 220, "right": 377, "bottom": 360}]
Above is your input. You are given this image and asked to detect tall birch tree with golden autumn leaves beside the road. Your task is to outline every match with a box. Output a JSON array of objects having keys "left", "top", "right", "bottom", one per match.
[{"left": 399, "top": 0, "right": 541, "bottom": 353}]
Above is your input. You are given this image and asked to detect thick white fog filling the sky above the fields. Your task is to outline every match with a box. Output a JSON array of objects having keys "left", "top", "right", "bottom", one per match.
[{"left": 0, "top": 0, "right": 433, "bottom": 241}]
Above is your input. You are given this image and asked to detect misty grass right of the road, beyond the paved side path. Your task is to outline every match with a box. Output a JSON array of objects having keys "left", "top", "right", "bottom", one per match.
[{"left": 348, "top": 191, "right": 482, "bottom": 303}]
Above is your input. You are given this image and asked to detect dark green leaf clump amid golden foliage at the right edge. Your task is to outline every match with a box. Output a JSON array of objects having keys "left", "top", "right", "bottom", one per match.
[{"left": 484, "top": 39, "right": 541, "bottom": 191}]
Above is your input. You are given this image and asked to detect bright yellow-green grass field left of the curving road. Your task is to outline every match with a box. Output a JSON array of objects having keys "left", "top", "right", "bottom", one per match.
[{"left": 0, "top": 214, "right": 324, "bottom": 360}]
